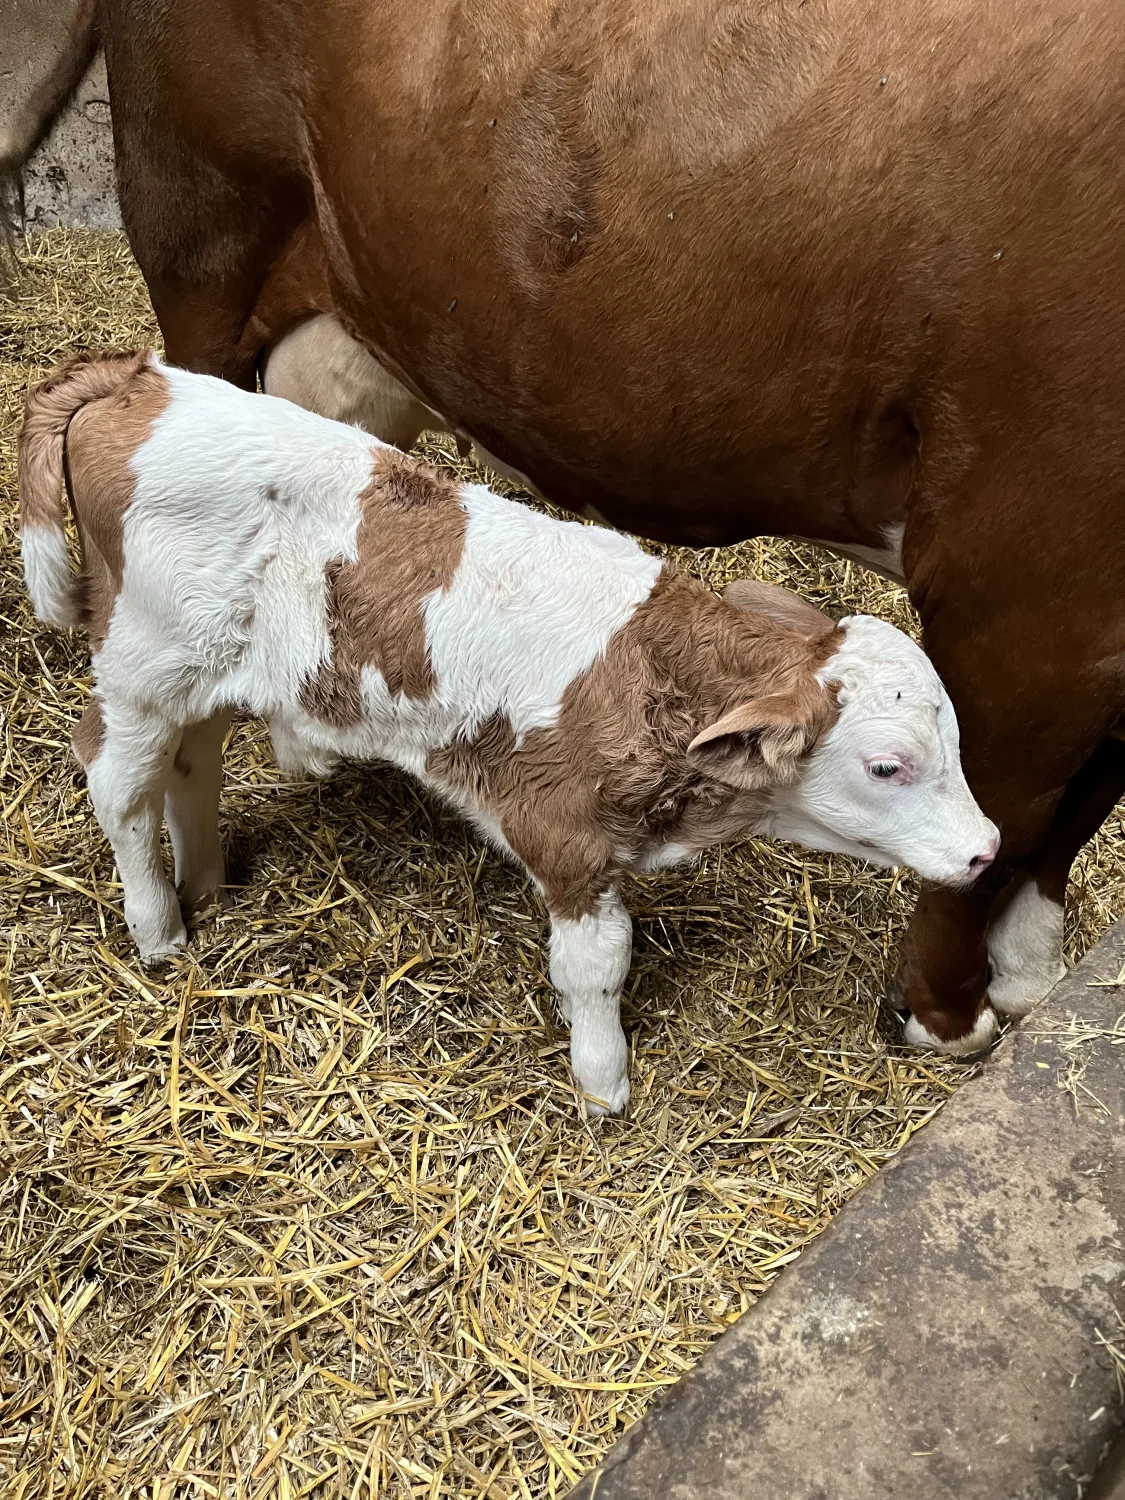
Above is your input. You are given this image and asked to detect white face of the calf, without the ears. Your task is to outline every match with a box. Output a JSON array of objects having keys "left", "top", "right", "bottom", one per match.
[{"left": 756, "top": 615, "right": 999, "bottom": 885}]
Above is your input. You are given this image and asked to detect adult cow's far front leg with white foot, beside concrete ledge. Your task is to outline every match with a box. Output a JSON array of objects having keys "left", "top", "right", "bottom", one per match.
[{"left": 989, "top": 740, "right": 1125, "bottom": 1016}]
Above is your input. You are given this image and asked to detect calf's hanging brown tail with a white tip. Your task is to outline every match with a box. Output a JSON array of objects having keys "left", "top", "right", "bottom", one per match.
[{"left": 20, "top": 350, "right": 149, "bottom": 630}]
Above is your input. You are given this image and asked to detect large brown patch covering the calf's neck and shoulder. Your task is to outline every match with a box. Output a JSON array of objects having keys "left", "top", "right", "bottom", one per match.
[{"left": 428, "top": 567, "right": 840, "bottom": 918}]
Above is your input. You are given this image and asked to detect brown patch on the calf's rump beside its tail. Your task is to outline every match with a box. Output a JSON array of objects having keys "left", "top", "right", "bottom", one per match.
[{"left": 58, "top": 361, "right": 171, "bottom": 651}]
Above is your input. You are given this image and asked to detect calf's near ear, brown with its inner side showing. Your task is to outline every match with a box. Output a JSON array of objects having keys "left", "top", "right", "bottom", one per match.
[{"left": 687, "top": 689, "right": 828, "bottom": 792}]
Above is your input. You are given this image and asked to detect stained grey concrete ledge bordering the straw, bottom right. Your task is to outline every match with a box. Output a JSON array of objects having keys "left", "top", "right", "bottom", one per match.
[{"left": 572, "top": 921, "right": 1125, "bottom": 1500}]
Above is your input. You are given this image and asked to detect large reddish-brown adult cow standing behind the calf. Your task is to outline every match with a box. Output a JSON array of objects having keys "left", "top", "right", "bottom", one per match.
[{"left": 8, "top": 0, "right": 1125, "bottom": 1043}]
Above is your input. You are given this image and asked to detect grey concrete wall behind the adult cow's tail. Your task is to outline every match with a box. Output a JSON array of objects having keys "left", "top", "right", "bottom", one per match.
[{"left": 0, "top": 0, "right": 122, "bottom": 230}]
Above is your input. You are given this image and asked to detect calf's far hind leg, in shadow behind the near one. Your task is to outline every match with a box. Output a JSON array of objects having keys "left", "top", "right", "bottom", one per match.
[{"left": 164, "top": 710, "right": 231, "bottom": 906}]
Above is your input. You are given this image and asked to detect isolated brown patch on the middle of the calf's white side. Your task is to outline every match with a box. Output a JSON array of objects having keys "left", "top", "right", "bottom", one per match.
[{"left": 300, "top": 449, "right": 465, "bottom": 729}]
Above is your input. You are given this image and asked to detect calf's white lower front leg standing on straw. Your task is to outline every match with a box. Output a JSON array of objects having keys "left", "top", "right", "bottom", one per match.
[{"left": 551, "top": 888, "right": 633, "bottom": 1115}]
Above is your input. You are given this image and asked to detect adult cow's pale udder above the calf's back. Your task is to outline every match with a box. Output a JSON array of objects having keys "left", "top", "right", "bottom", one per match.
[{"left": 263, "top": 314, "right": 446, "bottom": 449}]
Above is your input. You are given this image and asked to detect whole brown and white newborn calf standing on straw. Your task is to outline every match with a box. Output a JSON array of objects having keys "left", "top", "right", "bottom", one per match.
[{"left": 20, "top": 351, "right": 998, "bottom": 1112}]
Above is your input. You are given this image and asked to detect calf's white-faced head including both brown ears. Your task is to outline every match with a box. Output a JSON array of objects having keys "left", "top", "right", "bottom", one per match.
[{"left": 690, "top": 581, "right": 999, "bottom": 885}]
